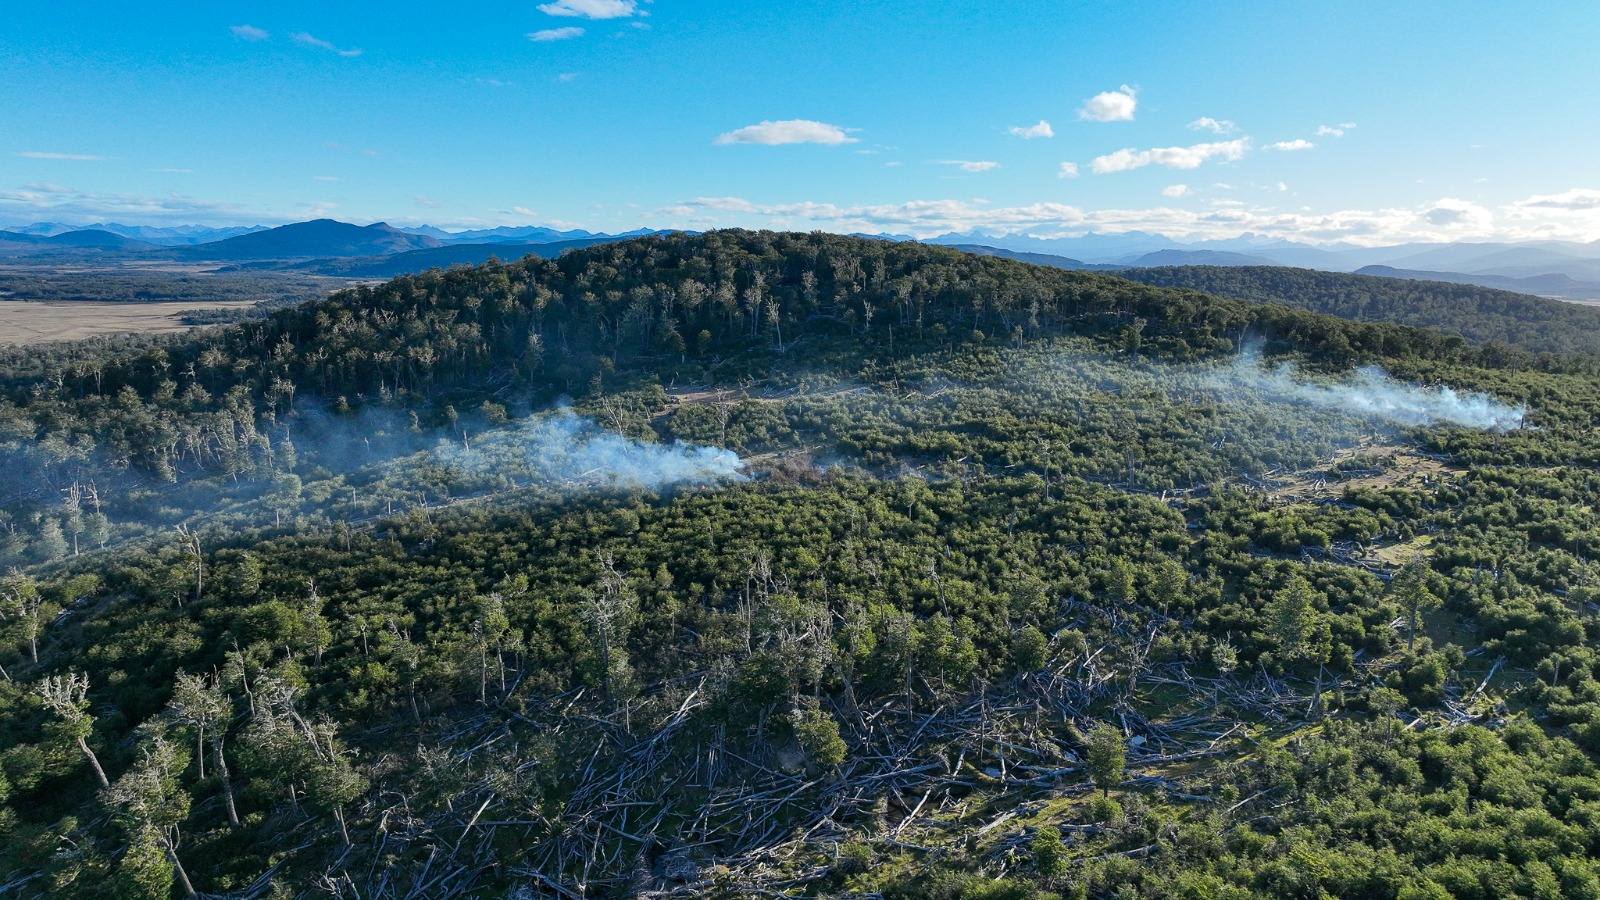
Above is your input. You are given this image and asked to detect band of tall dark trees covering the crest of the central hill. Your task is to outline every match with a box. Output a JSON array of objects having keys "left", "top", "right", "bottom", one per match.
[{"left": 0, "top": 231, "right": 1523, "bottom": 477}]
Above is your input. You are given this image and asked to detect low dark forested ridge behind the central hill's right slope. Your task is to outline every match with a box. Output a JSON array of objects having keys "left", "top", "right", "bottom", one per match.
[{"left": 1120, "top": 266, "right": 1600, "bottom": 354}]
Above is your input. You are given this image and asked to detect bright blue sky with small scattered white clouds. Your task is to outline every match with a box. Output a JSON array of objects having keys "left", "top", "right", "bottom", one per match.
[{"left": 0, "top": 0, "right": 1600, "bottom": 243}]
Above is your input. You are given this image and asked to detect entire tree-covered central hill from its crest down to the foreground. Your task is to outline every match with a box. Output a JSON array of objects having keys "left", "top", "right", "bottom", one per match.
[{"left": 0, "top": 232, "right": 1600, "bottom": 898}]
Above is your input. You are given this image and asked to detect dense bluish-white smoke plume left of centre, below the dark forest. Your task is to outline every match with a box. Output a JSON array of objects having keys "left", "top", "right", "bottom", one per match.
[{"left": 429, "top": 408, "right": 746, "bottom": 490}]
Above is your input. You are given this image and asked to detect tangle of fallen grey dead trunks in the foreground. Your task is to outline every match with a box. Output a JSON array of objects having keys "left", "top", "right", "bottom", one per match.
[{"left": 294, "top": 629, "right": 1344, "bottom": 898}]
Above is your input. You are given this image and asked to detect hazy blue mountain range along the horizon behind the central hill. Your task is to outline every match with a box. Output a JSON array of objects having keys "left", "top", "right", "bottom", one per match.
[{"left": 9, "top": 219, "right": 1600, "bottom": 299}]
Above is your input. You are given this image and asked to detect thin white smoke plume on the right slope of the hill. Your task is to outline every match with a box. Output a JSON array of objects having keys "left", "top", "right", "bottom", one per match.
[{"left": 1211, "top": 352, "right": 1526, "bottom": 431}]
